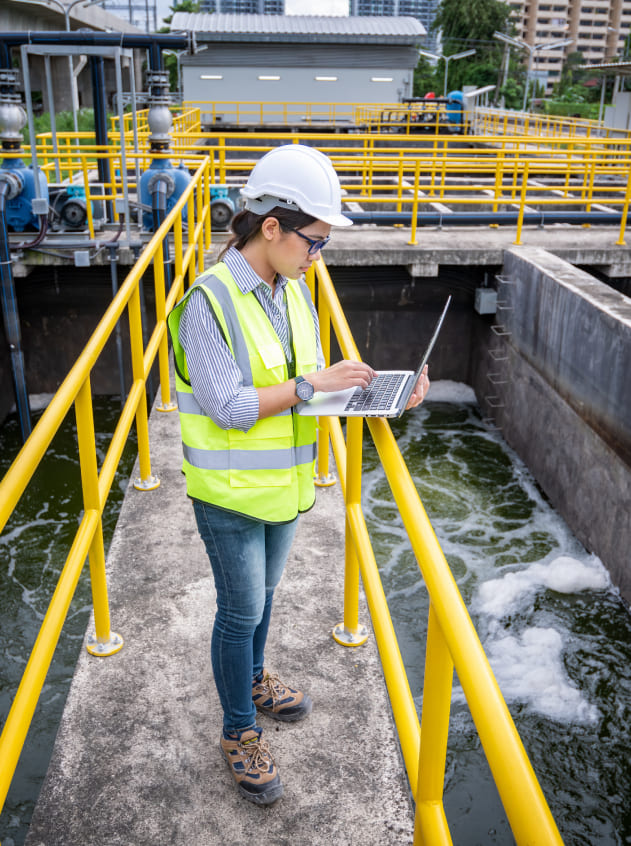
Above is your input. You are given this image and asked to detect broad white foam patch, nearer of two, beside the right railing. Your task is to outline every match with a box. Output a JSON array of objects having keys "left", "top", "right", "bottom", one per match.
[{"left": 486, "top": 627, "right": 600, "bottom": 724}]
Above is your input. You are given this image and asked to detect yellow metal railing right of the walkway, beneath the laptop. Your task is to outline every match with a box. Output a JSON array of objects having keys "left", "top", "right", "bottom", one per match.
[{"left": 308, "top": 260, "right": 563, "bottom": 846}]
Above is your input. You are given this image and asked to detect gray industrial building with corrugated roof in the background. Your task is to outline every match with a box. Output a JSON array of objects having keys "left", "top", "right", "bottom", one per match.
[{"left": 171, "top": 12, "right": 425, "bottom": 112}]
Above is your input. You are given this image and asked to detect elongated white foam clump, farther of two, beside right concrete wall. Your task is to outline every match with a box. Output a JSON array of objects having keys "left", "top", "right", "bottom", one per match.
[{"left": 475, "top": 555, "right": 611, "bottom": 619}]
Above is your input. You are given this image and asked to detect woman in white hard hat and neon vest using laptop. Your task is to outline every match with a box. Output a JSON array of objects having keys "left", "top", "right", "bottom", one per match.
[{"left": 169, "top": 144, "right": 429, "bottom": 805}]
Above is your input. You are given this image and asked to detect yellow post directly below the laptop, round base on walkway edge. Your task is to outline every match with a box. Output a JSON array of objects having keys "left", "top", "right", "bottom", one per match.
[{"left": 333, "top": 417, "right": 368, "bottom": 646}]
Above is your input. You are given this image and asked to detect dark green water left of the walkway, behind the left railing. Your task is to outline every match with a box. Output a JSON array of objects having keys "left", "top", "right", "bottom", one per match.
[{"left": 0, "top": 397, "right": 136, "bottom": 846}]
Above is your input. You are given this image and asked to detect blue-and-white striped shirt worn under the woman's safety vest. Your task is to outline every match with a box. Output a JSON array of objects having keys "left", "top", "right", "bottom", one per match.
[{"left": 179, "top": 247, "right": 324, "bottom": 432}]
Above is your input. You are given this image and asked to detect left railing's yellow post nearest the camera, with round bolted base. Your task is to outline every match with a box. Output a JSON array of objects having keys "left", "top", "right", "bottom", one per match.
[{"left": 75, "top": 376, "right": 123, "bottom": 657}]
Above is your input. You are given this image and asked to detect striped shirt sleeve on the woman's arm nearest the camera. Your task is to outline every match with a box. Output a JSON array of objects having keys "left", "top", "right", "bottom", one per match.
[{"left": 179, "top": 291, "right": 259, "bottom": 432}]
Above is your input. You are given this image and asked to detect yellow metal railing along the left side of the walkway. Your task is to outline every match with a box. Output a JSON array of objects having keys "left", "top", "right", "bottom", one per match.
[{"left": 0, "top": 160, "right": 211, "bottom": 824}]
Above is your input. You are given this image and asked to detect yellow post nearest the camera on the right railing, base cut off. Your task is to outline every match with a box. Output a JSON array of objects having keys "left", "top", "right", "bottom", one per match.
[{"left": 414, "top": 604, "right": 454, "bottom": 846}]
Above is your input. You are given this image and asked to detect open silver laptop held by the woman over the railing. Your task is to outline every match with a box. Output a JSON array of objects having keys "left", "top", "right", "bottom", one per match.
[{"left": 295, "top": 296, "right": 451, "bottom": 417}]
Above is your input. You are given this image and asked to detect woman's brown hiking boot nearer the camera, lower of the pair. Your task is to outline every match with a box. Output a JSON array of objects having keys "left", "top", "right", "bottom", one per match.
[{"left": 219, "top": 728, "right": 283, "bottom": 805}]
